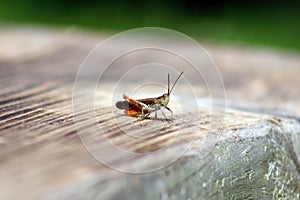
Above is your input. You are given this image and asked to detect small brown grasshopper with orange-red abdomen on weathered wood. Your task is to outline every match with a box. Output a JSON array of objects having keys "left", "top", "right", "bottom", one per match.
[{"left": 116, "top": 72, "right": 183, "bottom": 120}]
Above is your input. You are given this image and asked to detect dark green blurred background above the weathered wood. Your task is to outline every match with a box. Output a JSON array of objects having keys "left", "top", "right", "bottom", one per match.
[{"left": 0, "top": 0, "right": 300, "bottom": 52}]
